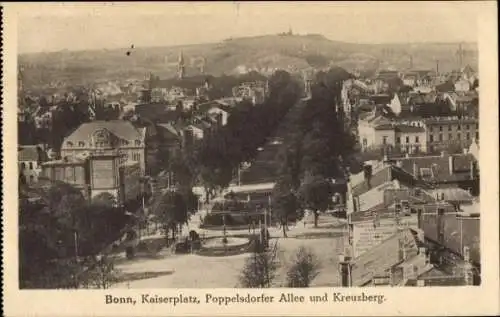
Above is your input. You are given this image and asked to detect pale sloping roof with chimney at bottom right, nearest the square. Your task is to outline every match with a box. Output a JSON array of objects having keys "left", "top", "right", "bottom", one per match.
[{"left": 351, "top": 229, "right": 418, "bottom": 286}]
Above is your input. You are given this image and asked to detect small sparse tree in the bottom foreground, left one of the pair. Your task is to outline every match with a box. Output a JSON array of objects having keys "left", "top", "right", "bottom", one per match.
[{"left": 240, "top": 239, "right": 278, "bottom": 288}]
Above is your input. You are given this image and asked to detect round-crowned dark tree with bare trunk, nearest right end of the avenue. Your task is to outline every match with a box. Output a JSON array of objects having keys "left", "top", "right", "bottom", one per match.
[{"left": 299, "top": 175, "right": 333, "bottom": 228}]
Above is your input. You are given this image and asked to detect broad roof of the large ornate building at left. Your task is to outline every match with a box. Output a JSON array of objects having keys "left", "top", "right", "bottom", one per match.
[{"left": 65, "top": 120, "right": 145, "bottom": 143}]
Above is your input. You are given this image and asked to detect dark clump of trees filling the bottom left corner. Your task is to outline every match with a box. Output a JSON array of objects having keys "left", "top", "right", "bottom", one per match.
[{"left": 19, "top": 183, "right": 130, "bottom": 288}]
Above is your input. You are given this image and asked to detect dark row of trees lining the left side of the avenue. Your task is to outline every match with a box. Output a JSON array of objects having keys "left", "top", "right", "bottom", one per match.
[{"left": 196, "top": 71, "right": 301, "bottom": 200}]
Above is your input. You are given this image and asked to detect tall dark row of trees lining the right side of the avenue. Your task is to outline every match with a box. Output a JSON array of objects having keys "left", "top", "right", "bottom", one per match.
[{"left": 273, "top": 67, "right": 355, "bottom": 237}]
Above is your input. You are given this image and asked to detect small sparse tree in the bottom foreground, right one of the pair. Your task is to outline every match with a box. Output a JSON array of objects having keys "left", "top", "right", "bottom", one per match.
[{"left": 287, "top": 247, "right": 320, "bottom": 287}]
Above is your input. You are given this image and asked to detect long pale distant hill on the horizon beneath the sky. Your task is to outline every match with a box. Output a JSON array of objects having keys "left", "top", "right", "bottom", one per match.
[{"left": 19, "top": 34, "right": 478, "bottom": 87}]
